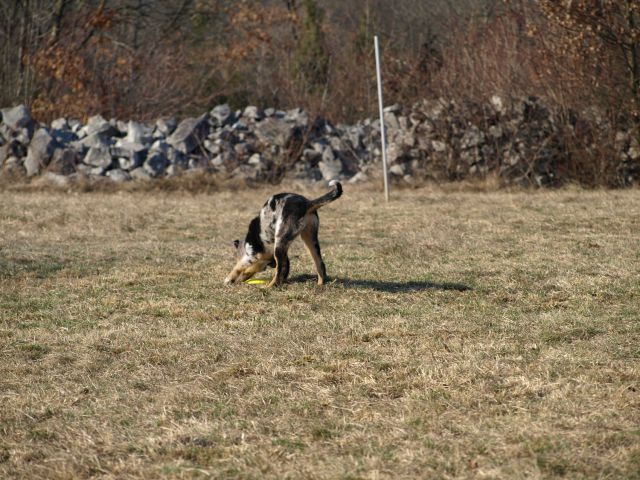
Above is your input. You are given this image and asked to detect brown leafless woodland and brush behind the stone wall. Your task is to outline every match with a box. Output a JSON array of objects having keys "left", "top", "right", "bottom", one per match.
[{"left": 0, "top": 0, "right": 640, "bottom": 123}]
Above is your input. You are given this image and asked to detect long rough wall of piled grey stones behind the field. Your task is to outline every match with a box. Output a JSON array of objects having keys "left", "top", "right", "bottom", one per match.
[{"left": 0, "top": 96, "right": 640, "bottom": 186}]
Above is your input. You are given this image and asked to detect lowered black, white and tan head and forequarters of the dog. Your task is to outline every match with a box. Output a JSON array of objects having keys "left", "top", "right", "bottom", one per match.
[{"left": 224, "top": 217, "right": 274, "bottom": 285}]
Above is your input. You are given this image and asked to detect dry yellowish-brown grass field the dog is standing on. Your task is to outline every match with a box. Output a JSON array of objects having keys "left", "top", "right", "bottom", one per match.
[{"left": 0, "top": 187, "right": 640, "bottom": 479}]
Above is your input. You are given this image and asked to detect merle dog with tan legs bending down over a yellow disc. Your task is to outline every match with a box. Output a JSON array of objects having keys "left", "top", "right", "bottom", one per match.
[{"left": 224, "top": 181, "right": 342, "bottom": 288}]
